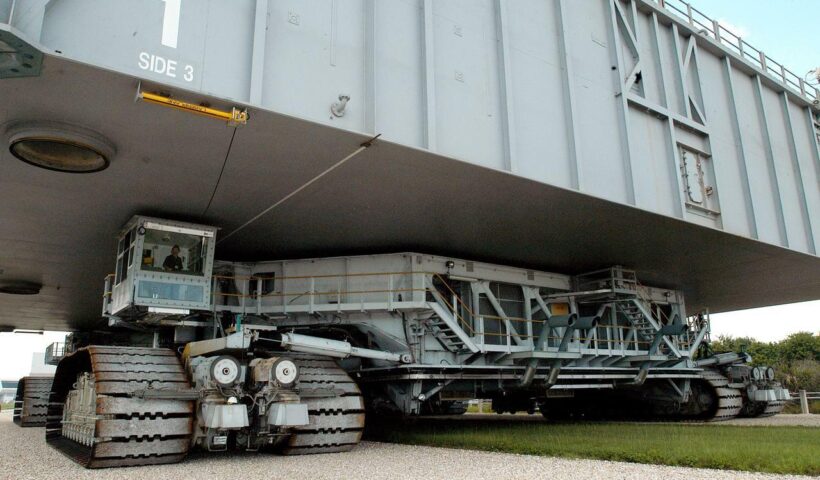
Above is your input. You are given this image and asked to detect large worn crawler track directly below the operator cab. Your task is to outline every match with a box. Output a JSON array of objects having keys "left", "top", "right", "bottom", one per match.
[{"left": 46, "top": 346, "right": 194, "bottom": 468}]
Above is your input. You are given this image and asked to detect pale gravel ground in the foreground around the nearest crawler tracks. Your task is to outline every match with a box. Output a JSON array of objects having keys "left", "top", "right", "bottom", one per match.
[{"left": 0, "top": 412, "right": 812, "bottom": 480}]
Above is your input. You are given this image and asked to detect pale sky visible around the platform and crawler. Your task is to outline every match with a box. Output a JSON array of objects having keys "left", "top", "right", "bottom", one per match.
[{"left": 0, "top": 0, "right": 820, "bottom": 380}]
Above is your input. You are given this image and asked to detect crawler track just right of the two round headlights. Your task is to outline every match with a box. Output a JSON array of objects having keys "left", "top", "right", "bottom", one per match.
[{"left": 281, "top": 355, "right": 364, "bottom": 455}]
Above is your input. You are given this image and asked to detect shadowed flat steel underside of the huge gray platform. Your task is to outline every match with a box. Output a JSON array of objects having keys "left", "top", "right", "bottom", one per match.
[{"left": 0, "top": 51, "right": 820, "bottom": 329}]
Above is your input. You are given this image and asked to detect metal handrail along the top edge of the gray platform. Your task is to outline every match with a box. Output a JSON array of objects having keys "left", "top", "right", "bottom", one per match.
[{"left": 646, "top": 0, "right": 820, "bottom": 103}]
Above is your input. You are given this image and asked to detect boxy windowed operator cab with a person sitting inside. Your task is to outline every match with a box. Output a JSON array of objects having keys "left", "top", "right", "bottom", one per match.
[{"left": 103, "top": 215, "right": 217, "bottom": 317}]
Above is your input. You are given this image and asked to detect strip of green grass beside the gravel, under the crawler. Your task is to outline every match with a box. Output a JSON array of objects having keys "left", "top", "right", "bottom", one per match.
[{"left": 368, "top": 418, "right": 820, "bottom": 475}]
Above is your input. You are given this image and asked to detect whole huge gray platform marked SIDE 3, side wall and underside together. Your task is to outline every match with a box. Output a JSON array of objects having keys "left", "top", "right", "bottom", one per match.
[{"left": 0, "top": 0, "right": 820, "bottom": 329}]
